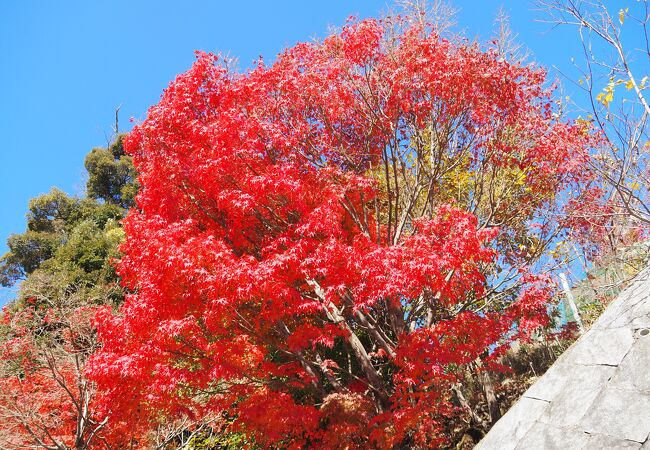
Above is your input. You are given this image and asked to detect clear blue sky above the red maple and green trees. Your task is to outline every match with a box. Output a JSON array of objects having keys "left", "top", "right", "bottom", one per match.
[{"left": 0, "top": 0, "right": 579, "bottom": 304}]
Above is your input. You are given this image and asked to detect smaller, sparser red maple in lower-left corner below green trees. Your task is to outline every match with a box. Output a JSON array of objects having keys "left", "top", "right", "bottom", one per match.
[{"left": 0, "top": 304, "right": 135, "bottom": 450}]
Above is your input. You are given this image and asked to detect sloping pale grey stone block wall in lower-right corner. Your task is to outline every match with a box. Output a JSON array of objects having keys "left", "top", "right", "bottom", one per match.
[{"left": 475, "top": 269, "right": 650, "bottom": 450}]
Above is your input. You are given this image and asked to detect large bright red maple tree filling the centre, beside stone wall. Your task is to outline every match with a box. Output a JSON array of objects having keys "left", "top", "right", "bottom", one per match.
[{"left": 89, "top": 17, "right": 591, "bottom": 448}]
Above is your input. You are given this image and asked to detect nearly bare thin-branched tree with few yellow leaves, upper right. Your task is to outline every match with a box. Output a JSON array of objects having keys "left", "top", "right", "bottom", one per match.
[{"left": 537, "top": 0, "right": 650, "bottom": 227}]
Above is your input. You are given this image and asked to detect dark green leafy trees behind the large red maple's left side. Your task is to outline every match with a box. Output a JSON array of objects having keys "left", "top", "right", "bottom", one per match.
[{"left": 0, "top": 138, "right": 136, "bottom": 303}]
